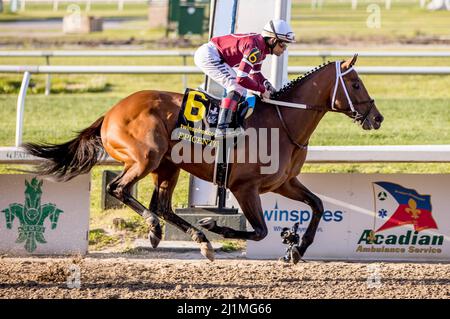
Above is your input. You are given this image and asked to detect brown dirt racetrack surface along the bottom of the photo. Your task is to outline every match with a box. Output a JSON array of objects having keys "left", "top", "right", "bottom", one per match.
[{"left": 0, "top": 251, "right": 450, "bottom": 299}]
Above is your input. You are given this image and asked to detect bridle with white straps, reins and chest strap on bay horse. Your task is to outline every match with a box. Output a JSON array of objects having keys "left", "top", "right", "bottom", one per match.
[{"left": 262, "top": 61, "right": 375, "bottom": 149}]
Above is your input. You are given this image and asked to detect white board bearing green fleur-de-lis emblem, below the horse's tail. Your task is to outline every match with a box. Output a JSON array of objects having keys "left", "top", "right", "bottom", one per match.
[{"left": 0, "top": 175, "right": 90, "bottom": 255}]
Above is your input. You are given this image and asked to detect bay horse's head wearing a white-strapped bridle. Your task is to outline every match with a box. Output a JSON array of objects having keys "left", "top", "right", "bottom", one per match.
[{"left": 331, "top": 54, "right": 384, "bottom": 130}]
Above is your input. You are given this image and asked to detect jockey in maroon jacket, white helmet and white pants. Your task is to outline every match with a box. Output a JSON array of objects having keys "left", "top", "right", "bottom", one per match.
[{"left": 194, "top": 20, "right": 295, "bottom": 138}]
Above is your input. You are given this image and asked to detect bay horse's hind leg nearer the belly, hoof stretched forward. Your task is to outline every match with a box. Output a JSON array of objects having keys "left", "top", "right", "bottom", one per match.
[{"left": 150, "top": 160, "right": 214, "bottom": 261}]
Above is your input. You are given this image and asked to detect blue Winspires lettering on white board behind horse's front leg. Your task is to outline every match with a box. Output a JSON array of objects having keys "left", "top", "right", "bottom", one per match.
[{"left": 264, "top": 202, "right": 344, "bottom": 225}]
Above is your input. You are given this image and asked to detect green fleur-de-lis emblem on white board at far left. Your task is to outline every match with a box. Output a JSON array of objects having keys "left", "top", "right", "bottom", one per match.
[{"left": 1, "top": 177, "right": 63, "bottom": 253}]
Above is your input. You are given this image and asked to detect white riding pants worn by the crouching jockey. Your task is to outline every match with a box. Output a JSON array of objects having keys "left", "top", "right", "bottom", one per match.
[{"left": 194, "top": 42, "right": 247, "bottom": 96}]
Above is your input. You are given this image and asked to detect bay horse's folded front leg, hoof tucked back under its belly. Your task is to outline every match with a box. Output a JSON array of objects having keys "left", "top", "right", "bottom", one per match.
[{"left": 199, "top": 187, "right": 267, "bottom": 241}]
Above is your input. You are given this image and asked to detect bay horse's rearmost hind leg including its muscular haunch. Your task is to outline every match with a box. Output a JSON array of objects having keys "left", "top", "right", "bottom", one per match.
[{"left": 101, "top": 111, "right": 169, "bottom": 248}]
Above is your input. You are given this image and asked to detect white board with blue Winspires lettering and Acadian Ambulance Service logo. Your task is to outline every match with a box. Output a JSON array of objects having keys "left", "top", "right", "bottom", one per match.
[{"left": 247, "top": 174, "right": 450, "bottom": 261}]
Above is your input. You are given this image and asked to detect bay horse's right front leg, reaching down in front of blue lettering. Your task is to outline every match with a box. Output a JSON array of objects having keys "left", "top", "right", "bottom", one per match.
[{"left": 274, "top": 177, "right": 323, "bottom": 262}]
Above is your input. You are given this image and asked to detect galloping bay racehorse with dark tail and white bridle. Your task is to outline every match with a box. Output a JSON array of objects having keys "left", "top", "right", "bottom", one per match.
[{"left": 23, "top": 55, "right": 383, "bottom": 262}]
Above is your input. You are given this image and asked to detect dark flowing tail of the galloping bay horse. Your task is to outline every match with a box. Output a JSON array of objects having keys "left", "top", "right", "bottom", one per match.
[{"left": 22, "top": 116, "right": 106, "bottom": 181}]
